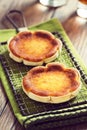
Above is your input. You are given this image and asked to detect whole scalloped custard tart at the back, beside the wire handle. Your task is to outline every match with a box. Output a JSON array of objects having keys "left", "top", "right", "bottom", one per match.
[{"left": 8, "top": 30, "right": 62, "bottom": 66}]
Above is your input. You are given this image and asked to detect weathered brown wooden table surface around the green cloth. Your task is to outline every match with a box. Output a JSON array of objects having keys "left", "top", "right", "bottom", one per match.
[{"left": 0, "top": 0, "right": 87, "bottom": 130}]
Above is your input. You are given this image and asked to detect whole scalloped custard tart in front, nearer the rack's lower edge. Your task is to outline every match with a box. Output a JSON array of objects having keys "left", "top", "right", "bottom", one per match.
[{"left": 23, "top": 62, "right": 81, "bottom": 103}]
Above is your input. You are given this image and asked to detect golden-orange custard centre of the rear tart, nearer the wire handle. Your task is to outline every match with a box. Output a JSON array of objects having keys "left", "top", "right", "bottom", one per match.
[{"left": 14, "top": 38, "right": 53, "bottom": 58}]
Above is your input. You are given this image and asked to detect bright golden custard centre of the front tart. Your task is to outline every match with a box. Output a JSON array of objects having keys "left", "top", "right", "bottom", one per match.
[{"left": 31, "top": 72, "right": 72, "bottom": 96}]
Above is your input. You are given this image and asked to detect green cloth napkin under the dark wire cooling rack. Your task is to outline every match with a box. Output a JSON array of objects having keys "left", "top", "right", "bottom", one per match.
[{"left": 0, "top": 19, "right": 87, "bottom": 129}]
